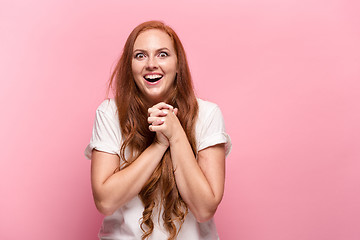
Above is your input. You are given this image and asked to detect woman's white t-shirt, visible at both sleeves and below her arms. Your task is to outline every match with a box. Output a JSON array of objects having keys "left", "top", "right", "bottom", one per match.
[{"left": 85, "top": 99, "right": 231, "bottom": 240}]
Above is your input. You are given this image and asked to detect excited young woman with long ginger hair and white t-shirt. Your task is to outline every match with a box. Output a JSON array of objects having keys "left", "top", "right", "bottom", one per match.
[{"left": 85, "top": 21, "right": 231, "bottom": 240}]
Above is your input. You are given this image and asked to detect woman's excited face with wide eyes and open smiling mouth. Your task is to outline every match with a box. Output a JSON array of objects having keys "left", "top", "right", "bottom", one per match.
[{"left": 131, "top": 29, "right": 177, "bottom": 104}]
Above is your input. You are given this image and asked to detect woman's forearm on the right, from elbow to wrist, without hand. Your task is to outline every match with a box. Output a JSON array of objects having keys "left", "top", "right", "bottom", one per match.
[{"left": 170, "top": 132, "right": 222, "bottom": 222}]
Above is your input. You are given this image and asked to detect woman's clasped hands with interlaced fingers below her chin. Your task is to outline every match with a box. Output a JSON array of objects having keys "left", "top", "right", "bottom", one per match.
[{"left": 148, "top": 102, "right": 182, "bottom": 147}]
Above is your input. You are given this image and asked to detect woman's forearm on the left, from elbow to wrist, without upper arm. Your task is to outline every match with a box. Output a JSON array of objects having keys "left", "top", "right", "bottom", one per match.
[{"left": 93, "top": 143, "right": 166, "bottom": 215}]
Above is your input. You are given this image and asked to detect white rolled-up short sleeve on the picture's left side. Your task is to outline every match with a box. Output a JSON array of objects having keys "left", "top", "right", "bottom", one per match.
[{"left": 84, "top": 100, "right": 121, "bottom": 159}]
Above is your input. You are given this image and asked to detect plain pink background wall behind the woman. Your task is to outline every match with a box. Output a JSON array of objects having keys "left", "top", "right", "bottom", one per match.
[{"left": 0, "top": 0, "right": 360, "bottom": 240}]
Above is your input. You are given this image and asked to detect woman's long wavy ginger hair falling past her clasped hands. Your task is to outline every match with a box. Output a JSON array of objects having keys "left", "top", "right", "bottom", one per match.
[{"left": 109, "top": 21, "right": 198, "bottom": 240}]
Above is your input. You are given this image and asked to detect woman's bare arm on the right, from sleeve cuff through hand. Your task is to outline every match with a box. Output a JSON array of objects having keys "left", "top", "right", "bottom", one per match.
[{"left": 149, "top": 104, "right": 225, "bottom": 222}]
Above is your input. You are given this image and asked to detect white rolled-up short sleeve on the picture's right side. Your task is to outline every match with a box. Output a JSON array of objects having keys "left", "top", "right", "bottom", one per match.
[{"left": 198, "top": 104, "right": 232, "bottom": 156}]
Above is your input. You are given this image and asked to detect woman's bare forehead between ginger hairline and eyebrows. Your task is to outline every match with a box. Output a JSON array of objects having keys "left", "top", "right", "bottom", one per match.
[{"left": 134, "top": 29, "right": 174, "bottom": 51}]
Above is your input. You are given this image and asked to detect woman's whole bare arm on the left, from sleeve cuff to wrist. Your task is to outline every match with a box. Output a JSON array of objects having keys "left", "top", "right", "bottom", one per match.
[{"left": 91, "top": 142, "right": 167, "bottom": 215}]
